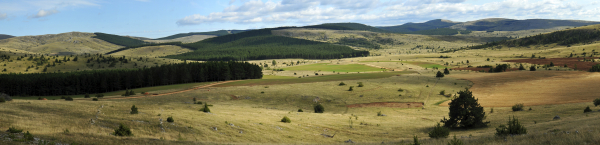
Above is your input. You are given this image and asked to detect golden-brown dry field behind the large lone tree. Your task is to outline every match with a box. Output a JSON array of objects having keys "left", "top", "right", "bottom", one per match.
[{"left": 440, "top": 71, "right": 600, "bottom": 107}]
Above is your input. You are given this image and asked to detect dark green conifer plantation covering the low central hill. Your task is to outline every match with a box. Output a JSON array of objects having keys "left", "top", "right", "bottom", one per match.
[{"left": 166, "top": 35, "right": 369, "bottom": 61}]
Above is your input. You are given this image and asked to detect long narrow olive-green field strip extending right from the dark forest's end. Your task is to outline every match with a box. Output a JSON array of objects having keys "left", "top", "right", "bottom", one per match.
[{"left": 215, "top": 71, "right": 414, "bottom": 87}]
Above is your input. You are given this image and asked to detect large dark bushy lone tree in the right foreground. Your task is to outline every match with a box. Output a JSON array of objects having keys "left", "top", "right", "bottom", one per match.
[{"left": 441, "top": 89, "right": 489, "bottom": 128}]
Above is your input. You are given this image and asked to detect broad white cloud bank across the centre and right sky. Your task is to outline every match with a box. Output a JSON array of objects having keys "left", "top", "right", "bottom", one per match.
[{"left": 177, "top": 0, "right": 598, "bottom": 26}]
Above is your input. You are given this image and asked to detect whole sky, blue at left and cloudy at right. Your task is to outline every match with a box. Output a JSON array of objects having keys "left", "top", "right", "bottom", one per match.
[{"left": 0, "top": 0, "right": 600, "bottom": 38}]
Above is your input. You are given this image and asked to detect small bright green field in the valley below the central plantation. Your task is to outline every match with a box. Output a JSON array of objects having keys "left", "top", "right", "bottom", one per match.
[{"left": 284, "top": 63, "right": 381, "bottom": 72}]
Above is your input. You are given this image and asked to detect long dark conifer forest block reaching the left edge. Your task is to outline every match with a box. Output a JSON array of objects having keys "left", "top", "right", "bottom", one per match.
[{"left": 0, "top": 61, "right": 262, "bottom": 96}]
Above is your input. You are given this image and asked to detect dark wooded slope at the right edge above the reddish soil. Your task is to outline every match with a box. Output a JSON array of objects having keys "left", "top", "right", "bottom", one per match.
[{"left": 452, "top": 25, "right": 600, "bottom": 49}]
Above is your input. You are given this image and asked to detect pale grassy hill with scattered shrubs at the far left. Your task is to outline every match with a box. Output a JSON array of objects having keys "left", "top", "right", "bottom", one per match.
[{"left": 0, "top": 32, "right": 121, "bottom": 54}]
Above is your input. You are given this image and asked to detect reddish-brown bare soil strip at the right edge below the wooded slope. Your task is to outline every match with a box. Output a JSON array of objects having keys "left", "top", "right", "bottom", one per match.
[{"left": 504, "top": 57, "right": 600, "bottom": 71}]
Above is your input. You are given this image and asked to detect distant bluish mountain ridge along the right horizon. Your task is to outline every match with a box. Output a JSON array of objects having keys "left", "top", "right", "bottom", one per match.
[{"left": 377, "top": 18, "right": 600, "bottom": 33}]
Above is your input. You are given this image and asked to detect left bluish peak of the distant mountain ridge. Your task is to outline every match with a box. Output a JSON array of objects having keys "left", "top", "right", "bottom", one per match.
[{"left": 378, "top": 19, "right": 457, "bottom": 33}]
